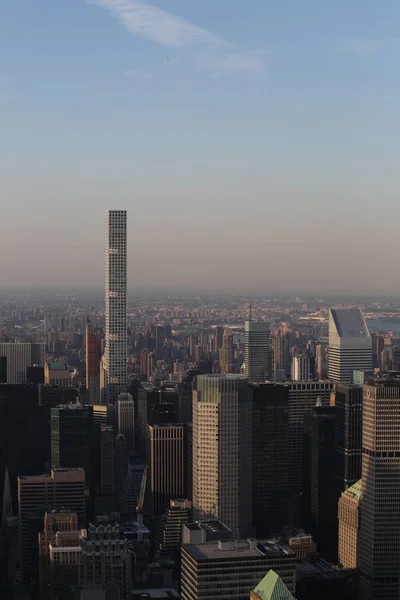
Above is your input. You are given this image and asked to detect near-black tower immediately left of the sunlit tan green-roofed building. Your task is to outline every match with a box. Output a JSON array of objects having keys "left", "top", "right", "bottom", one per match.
[{"left": 304, "top": 405, "right": 338, "bottom": 561}]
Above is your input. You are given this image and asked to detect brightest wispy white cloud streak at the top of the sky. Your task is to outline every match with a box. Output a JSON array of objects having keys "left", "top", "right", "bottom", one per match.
[{"left": 86, "top": 0, "right": 265, "bottom": 73}]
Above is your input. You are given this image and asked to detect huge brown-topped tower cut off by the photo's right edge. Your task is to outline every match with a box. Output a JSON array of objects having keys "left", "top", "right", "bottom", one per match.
[{"left": 360, "top": 373, "right": 400, "bottom": 600}]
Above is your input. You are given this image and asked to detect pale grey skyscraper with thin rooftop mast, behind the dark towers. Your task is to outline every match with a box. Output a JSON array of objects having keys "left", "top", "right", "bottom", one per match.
[{"left": 245, "top": 321, "right": 272, "bottom": 383}]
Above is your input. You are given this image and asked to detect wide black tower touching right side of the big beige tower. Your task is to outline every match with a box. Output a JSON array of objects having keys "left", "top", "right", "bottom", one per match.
[{"left": 250, "top": 383, "right": 289, "bottom": 539}]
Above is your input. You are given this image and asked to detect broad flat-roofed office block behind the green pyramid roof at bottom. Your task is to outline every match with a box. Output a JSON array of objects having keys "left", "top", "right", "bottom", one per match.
[{"left": 181, "top": 539, "right": 296, "bottom": 600}]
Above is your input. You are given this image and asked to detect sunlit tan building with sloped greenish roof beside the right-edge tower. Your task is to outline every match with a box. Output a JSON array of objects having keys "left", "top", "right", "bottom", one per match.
[{"left": 338, "top": 479, "right": 362, "bottom": 569}]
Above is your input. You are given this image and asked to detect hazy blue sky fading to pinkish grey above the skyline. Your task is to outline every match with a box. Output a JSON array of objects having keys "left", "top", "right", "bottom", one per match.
[{"left": 0, "top": 0, "right": 400, "bottom": 296}]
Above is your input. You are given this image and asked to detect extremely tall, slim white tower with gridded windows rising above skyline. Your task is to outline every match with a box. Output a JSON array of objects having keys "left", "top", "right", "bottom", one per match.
[{"left": 105, "top": 210, "right": 127, "bottom": 402}]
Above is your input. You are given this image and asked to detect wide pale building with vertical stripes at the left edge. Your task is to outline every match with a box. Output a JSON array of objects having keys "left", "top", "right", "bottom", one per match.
[{"left": 0, "top": 342, "right": 44, "bottom": 384}]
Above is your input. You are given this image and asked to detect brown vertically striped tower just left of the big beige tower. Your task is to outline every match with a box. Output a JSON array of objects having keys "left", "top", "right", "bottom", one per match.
[{"left": 148, "top": 424, "right": 187, "bottom": 517}]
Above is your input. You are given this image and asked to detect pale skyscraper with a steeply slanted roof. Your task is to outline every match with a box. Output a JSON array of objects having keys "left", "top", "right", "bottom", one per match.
[{"left": 328, "top": 308, "right": 372, "bottom": 383}]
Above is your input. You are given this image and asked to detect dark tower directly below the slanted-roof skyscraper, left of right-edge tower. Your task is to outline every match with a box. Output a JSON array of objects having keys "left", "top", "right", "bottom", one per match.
[{"left": 335, "top": 385, "right": 363, "bottom": 496}]
